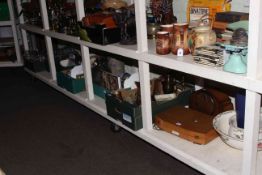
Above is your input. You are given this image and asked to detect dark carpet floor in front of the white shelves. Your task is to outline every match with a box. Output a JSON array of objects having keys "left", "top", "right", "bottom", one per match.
[{"left": 0, "top": 68, "right": 203, "bottom": 175}]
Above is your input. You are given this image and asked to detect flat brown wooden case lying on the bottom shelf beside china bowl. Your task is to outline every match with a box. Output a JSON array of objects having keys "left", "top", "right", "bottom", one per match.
[{"left": 155, "top": 106, "right": 218, "bottom": 144}]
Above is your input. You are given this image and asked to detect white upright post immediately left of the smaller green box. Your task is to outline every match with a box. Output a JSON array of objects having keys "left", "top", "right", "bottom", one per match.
[{"left": 39, "top": 0, "right": 56, "bottom": 80}]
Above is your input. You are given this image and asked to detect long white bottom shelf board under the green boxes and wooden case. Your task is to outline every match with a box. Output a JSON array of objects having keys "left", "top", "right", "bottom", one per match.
[{"left": 26, "top": 70, "right": 262, "bottom": 175}]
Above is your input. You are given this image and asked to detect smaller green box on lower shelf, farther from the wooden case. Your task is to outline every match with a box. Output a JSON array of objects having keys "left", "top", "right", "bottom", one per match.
[{"left": 56, "top": 71, "right": 85, "bottom": 94}]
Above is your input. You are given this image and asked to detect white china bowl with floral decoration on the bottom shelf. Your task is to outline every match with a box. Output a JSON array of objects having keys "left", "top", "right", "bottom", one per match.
[{"left": 213, "top": 111, "right": 262, "bottom": 151}]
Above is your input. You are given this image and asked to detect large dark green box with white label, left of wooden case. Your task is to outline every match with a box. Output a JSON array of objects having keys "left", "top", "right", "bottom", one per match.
[{"left": 105, "top": 88, "right": 193, "bottom": 131}]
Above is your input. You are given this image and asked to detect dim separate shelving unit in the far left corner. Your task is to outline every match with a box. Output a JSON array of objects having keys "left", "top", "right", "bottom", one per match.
[{"left": 0, "top": 0, "right": 23, "bottom": 67}]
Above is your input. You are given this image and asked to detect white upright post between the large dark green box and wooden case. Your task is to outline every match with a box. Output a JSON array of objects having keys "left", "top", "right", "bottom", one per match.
[{"left": 134, "top": 0, "right": 153, "bottom": 130}]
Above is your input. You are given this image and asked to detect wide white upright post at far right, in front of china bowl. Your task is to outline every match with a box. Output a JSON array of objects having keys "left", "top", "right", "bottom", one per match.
[{"left": 242, "top": 0, "right": 262, "bottom": 175}]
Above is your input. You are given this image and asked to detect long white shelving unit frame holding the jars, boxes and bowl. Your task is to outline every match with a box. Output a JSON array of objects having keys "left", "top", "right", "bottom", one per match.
[{"left": 17, "top": 0, "right": 262, "bottom": 175}]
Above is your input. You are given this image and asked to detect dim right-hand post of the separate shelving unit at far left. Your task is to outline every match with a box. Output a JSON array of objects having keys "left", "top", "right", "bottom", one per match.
[{"left": 7, "top": 0, "right": 22, "bottom": 64}]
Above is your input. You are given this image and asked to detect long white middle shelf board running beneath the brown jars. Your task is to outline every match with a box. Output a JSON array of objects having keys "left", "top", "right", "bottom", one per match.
[{"left": 20, "top": 24, "right": 262, "bottom": 93}]
